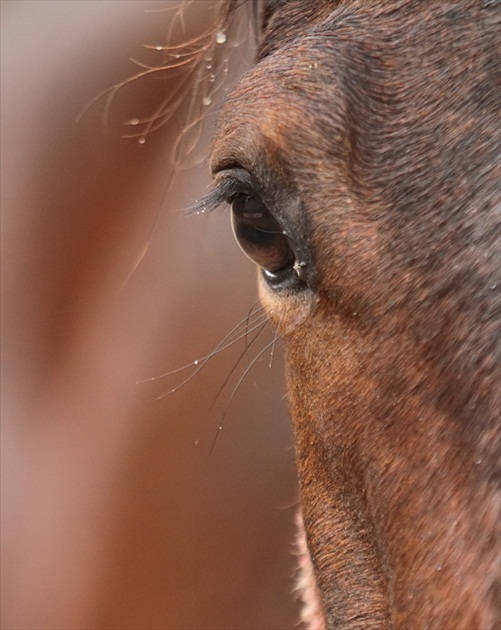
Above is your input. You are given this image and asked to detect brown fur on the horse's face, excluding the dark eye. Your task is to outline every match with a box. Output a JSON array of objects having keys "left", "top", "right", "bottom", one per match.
[{"left": 204, "top": 0, "right": 501, "bottom": 629}]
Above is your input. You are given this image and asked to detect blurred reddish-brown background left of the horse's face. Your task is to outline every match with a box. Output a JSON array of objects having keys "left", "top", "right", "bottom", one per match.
[{"left": 1, "top": 0, "right": 297, "bottom": 630}]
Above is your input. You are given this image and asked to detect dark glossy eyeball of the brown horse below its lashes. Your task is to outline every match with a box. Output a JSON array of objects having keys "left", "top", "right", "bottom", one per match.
[{"left": 231, "top": 194, "right": 295, "bottom": 283}]
